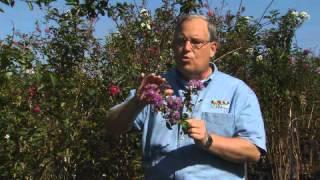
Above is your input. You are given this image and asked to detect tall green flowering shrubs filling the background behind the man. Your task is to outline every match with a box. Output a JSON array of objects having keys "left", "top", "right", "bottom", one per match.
[{"left": 0, "top": 0, "right": 320, "bottom": 179}]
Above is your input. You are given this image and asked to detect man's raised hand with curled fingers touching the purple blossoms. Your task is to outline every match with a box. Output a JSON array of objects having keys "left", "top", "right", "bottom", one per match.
[{"left": 136, "top": 73, "right": 173, "bottom": 104}]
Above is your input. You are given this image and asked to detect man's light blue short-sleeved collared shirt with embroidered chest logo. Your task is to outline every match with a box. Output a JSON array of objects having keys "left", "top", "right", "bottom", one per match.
[{"left": 127, "top": 64, "right": 266, "bottom": 180}]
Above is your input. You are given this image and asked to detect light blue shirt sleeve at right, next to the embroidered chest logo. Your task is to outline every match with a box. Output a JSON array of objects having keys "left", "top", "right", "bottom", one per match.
[{"left": 235, "top": 85, "right": 267, "bottom": 153}]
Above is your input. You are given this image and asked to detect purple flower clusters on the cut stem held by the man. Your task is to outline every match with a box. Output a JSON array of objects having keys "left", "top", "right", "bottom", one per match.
[{"left": 142, "top": 80, "right": 204, "bottom": 129}]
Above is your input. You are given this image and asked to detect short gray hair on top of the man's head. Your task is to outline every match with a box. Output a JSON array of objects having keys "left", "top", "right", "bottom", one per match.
[{"left": 175, "top": 14, "right": 218, "bottom": 41}]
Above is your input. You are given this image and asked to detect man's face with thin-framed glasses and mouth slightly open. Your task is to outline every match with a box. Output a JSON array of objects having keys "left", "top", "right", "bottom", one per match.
[{"left": 174, "top": 18, "right": 216, "bottom": 78}]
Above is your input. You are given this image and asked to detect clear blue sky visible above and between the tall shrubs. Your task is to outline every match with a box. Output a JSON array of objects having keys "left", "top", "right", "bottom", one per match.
[{"left": 0, "top": 0, "right": 320, "bottom": 54}]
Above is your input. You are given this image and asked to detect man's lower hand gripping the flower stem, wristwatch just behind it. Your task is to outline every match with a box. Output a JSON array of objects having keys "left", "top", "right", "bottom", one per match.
[{"left": 186, "top": 119, "right": 209, "bottom": 146}]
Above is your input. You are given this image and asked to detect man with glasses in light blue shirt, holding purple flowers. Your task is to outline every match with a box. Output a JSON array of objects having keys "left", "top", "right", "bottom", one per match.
[{"left": 107, "top": 15, "right": 266, "bottom": 180}]
